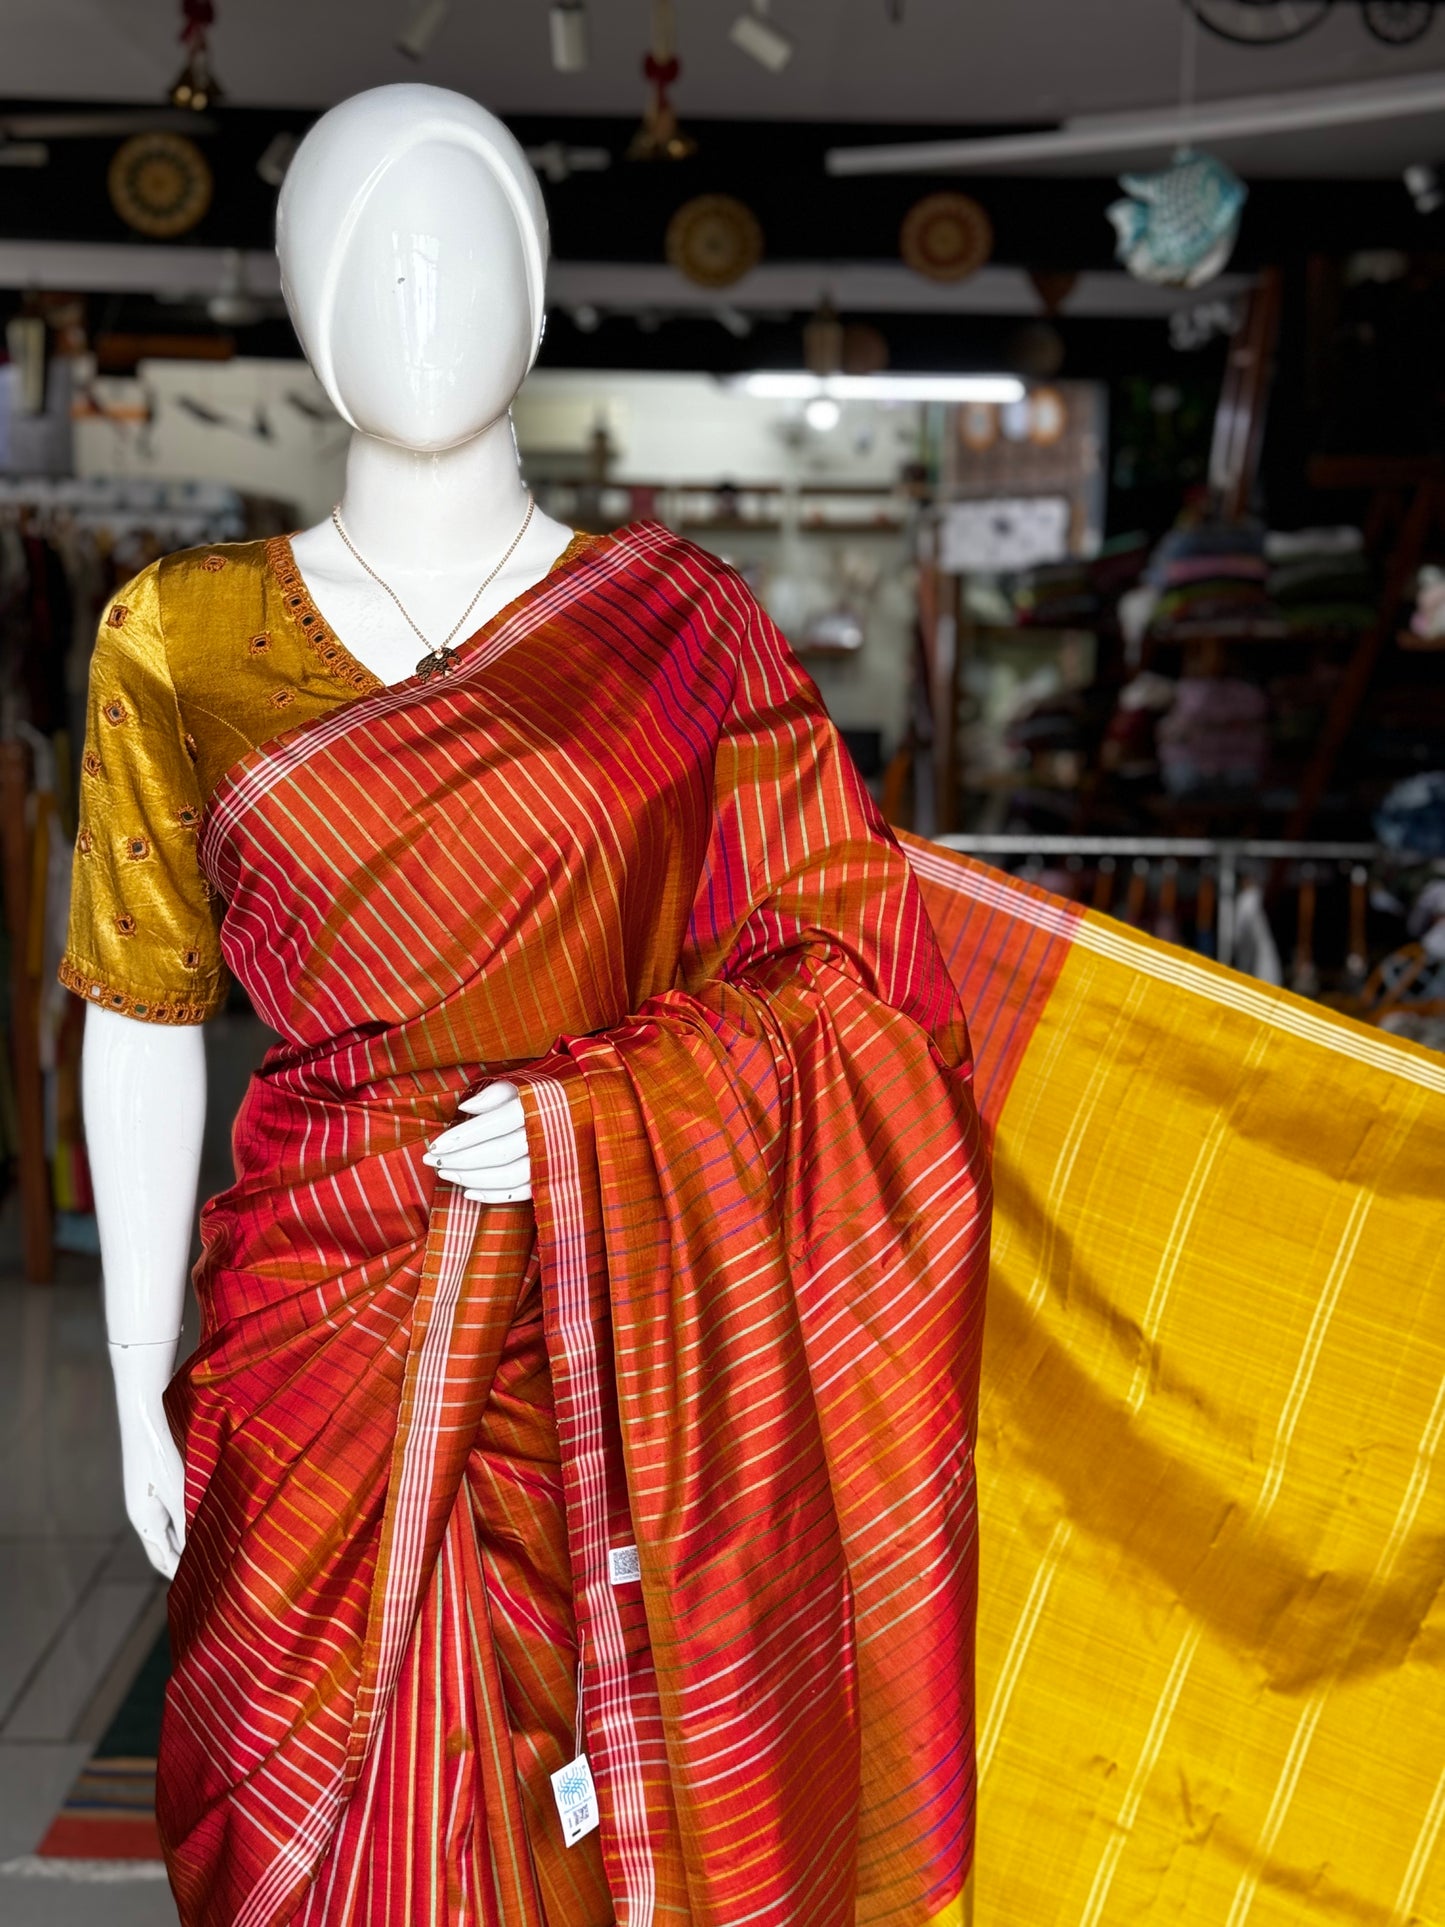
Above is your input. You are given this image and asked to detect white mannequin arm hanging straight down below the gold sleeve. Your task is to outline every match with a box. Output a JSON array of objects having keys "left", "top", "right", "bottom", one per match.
[{"left": 81, "top": 1006, "right": 206, "bottom": 1578}]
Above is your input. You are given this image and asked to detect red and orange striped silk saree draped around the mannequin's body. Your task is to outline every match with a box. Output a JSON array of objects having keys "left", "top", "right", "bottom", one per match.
[{"left": 158, "top": 526, "right": 988, "bottom": 1927}]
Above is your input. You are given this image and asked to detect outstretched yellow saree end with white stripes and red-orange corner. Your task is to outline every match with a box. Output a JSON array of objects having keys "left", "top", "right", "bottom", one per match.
[{"left": 907, "top": 840, "right": 1445, "bottom": 1927}]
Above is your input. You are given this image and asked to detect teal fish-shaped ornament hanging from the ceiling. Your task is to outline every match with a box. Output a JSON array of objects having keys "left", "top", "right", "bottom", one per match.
[{"left": 1108, "top": 146, "right": 1248, "bottom": 287}]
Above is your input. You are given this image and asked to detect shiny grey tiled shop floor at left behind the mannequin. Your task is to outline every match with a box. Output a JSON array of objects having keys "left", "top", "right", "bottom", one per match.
[{"left": 0, "top": 1017, "right": 266, "bottom": 1927}]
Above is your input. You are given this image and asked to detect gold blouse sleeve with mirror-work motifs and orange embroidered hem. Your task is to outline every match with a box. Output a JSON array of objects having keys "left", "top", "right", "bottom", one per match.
[{"left": 60, "top": 567, "right": 227, "bottom": 1023}]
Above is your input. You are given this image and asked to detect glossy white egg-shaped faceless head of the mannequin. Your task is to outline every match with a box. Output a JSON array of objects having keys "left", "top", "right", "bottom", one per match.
[{"left": 276, "top": 85, "right": 547, "bottom": 451}]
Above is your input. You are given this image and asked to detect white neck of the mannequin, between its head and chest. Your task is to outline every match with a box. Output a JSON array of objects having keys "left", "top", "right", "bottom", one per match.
[{"left": 341, "top": 414, "right": 526, "bottom": 574}]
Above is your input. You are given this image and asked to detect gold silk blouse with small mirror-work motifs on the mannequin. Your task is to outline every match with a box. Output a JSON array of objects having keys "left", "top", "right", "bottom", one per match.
[{"left": 60, "top": 536, "right": 591, "bottom": 1023}]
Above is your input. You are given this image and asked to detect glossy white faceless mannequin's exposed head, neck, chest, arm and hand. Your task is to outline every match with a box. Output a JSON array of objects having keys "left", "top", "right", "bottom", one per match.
[{"left": 83, "top": 85, "right": 572, "bottom": 1578}]
